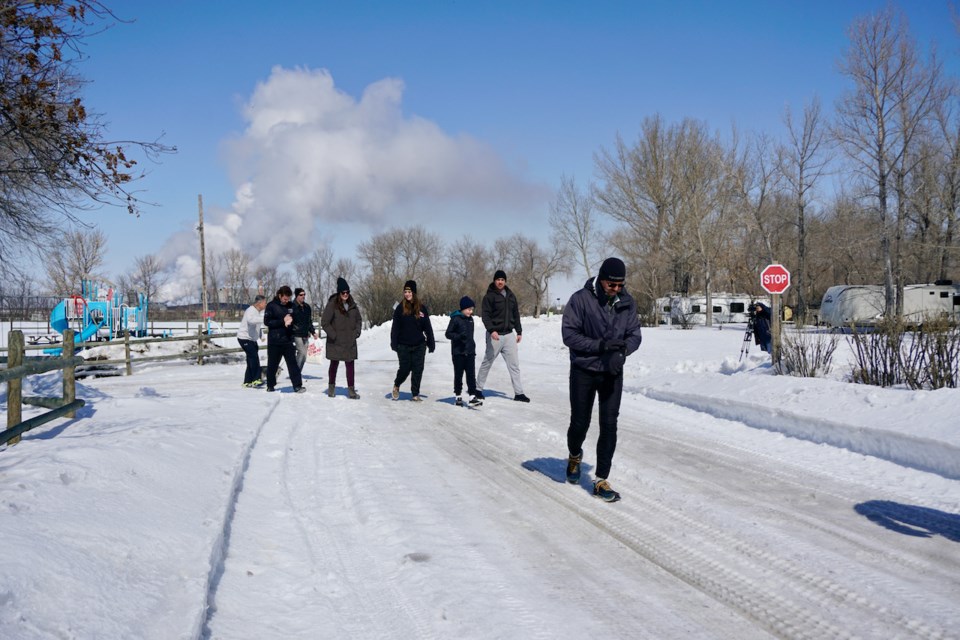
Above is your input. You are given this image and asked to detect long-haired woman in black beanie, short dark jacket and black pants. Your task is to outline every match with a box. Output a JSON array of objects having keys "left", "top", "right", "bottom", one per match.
[{"left": 390, "top": 280, "right": 437, "bottom": 402}]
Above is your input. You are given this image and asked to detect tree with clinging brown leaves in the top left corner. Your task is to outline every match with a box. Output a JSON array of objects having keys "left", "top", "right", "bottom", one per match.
[{"left": 0, "top": 0, "right": 174, "bottom": 264}]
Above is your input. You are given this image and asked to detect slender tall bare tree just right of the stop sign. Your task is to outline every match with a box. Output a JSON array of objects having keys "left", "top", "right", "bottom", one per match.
[{"left": 777, "top": 98, "right": 830, "bottom": 324}]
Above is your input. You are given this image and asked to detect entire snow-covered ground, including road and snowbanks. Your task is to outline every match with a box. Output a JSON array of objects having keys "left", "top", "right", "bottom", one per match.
[{"left": 0, "top": 317, "right": 960, "bottom": 640}]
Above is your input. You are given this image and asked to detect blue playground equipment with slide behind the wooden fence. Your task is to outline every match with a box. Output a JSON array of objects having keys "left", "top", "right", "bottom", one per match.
[{"left": 50, "top": 280, "right": 148, "bottom": 342}]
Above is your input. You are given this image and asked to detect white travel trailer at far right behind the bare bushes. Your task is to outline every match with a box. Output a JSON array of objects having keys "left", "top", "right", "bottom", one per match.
[{"left": 820, "top": 280, "right": 960, "bottom": 328}]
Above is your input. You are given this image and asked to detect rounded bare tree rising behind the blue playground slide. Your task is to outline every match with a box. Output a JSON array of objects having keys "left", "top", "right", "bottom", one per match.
[{"left": 45, "top": 228, "right": 107, "bottom": 295}]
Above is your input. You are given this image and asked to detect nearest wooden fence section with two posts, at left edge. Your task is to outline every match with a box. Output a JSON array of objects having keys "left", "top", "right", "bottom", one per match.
[{"left": 0, "top": 329, "right": 84, "bottom": 444}]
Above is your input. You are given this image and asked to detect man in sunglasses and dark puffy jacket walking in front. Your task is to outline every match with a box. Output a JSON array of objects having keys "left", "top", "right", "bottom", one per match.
[{"left": 561, "top": 258, "right": 640, "bottom": 502}]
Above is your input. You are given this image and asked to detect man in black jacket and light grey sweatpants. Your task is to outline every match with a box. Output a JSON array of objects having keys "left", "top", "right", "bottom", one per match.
[{"left": 477, "top": 269, "right": 530, "bottom": 402}]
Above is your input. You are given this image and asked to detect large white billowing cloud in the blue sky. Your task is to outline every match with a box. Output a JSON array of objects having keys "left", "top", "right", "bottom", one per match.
[{"left": 162, "top": 67, "right": 550, "bottom": 300}]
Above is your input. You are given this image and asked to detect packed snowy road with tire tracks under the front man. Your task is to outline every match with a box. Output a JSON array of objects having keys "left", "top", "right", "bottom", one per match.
[{"left": 204, "top": 344, "right": 960, "bottom": 639}]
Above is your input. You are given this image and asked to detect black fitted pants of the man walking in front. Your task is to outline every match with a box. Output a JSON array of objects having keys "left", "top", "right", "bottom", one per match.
[{"left": 567, "top": 366, "right": 623, "bottom": 478}]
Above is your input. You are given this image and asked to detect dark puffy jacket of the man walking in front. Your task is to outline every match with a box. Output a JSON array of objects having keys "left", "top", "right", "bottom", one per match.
[{"left": 561, "top": 278, "right": 641, "bottom": 373}]
